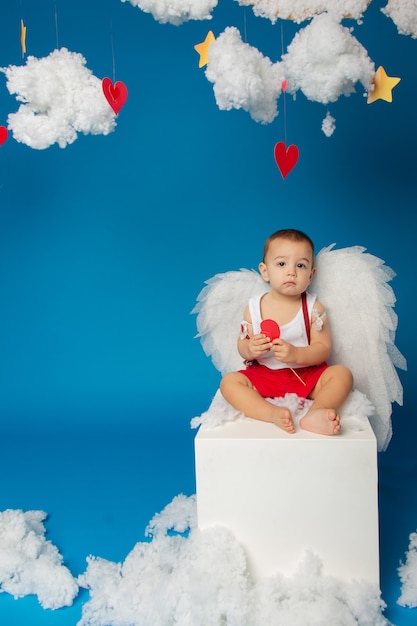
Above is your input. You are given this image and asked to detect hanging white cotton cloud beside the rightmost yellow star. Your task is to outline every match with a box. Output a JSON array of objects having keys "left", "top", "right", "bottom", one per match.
[{"left": 282, "top": 13, "right": 375, "bottom": 104}]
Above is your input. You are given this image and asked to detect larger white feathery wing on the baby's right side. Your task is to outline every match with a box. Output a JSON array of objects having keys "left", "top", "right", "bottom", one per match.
[{"left": 310, "top": 244, "right": 407, "bottom": 450}]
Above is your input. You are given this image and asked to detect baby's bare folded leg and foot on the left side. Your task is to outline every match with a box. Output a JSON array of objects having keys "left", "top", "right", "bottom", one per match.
[{"left": 220, "top": 372, "right": 295, "bottom": 433}]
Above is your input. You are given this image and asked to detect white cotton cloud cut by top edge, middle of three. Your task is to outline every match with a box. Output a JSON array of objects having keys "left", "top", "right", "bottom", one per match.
[{"left": 237, "top": 0, "right": 369, "bottom": 23}]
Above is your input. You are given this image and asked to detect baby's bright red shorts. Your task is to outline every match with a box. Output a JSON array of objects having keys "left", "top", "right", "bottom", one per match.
[{"left": 239, "top": 361, "right": 329, "bottom": 398}]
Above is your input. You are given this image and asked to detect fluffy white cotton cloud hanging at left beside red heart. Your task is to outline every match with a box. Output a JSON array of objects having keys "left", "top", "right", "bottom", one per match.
[{"left": 0, "top": 48, "right": 116, "bottom": 150}]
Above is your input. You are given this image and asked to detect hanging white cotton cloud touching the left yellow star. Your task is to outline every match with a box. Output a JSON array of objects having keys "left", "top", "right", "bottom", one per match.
[{"left": 206, "top": 27, "right": 284, "bottom": 123}]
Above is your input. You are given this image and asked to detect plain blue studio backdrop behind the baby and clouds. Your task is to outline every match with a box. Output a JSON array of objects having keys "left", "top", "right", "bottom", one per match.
[{"left": 0, "top": 0, "right": 417, "bottom": 626}]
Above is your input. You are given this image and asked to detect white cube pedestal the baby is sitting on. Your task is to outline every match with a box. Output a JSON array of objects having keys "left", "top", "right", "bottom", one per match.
[{"left": 195, "top": 419, "right": 379, "bottom": 588}]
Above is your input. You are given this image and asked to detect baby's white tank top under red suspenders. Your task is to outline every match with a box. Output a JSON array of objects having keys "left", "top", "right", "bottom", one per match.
[{"left": 248, "top": 292, "right": 317, "bottom": 370}]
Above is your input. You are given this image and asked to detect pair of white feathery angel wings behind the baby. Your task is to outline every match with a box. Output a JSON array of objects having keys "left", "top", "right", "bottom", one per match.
[{"left": 192, "top": 244, "right": 406, "bottom": 450}]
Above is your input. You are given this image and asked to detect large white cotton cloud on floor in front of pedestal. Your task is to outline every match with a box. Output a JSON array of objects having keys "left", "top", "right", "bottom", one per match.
[{"left": 78, "top": 495, "right": 388, "bottom": 626}]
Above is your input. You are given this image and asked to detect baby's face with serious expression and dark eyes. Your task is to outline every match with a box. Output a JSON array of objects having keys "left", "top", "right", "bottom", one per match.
[{"left": 259, "top": 239, "right": 315, "bottom": 296}]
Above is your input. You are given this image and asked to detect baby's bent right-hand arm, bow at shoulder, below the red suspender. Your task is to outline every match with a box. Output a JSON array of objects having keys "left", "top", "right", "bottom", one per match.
[{"left": 272, "top": 301, "right": 332, "bottom": 366}]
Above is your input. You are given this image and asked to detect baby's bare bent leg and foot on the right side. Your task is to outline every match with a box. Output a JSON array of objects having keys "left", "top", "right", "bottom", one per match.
[{"left": 300, "top": 365, "right": 353, "bottom": 435}]
